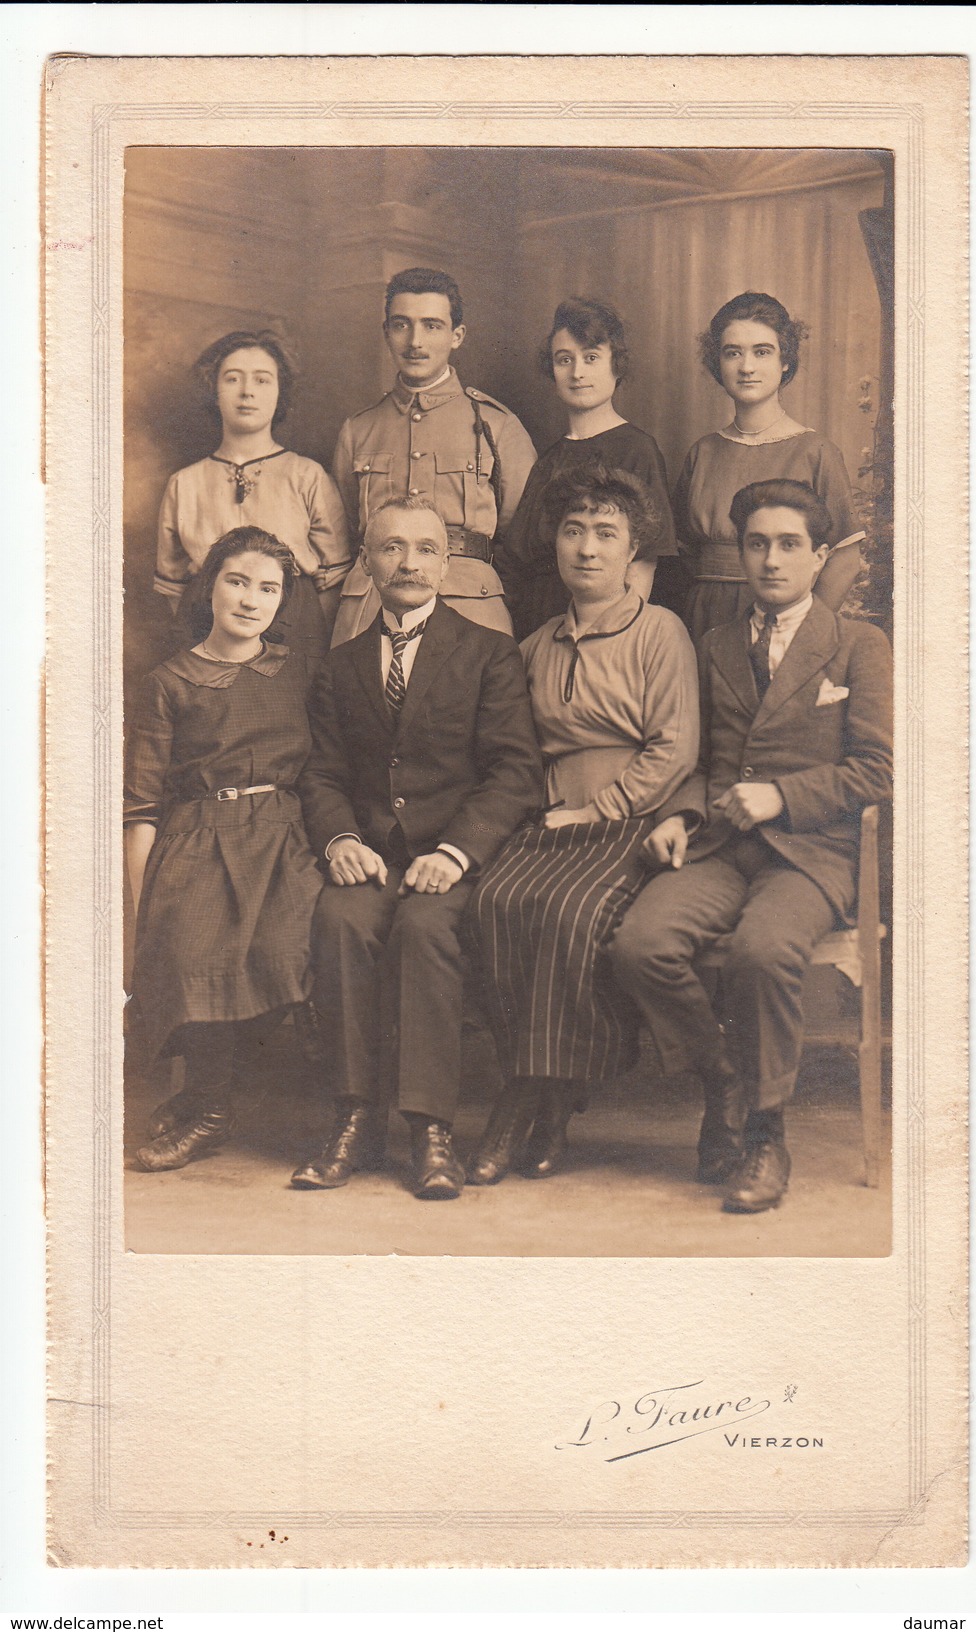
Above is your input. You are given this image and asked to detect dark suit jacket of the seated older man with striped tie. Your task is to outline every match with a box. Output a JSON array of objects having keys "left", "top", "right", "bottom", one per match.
[{"left": 299, "top": 601, "right": 543, "bottom": 867}]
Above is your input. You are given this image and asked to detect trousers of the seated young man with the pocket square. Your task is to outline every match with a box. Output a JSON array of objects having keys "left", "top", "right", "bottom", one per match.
[{"left": 610, "top": 834, "right": 836, "bottom": 1110}]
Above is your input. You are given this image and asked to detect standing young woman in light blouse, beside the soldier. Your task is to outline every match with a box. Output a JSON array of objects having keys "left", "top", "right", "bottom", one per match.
[{"left": 153, "top": 330, "right": 351, "bottom": 681}]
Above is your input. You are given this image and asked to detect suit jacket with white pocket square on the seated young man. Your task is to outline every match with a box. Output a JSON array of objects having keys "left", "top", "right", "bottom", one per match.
[{"left": 661, "top": 596, "right": 893, "bottom": 917}]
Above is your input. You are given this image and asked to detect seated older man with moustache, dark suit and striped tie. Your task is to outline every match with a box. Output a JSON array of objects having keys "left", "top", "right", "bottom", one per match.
[{"left": 292, "top": 496, "right": 543, "bottom": 1200}]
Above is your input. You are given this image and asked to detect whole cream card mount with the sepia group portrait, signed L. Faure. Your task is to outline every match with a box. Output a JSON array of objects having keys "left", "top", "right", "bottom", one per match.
[{"left": 44, "top": 55, "right": 968, "bottom": 1570}]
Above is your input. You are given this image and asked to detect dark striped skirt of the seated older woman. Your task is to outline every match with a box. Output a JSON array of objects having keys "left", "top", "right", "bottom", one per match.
[{"left": 472, "top": 816, "right": 654, "bottom": 1082}]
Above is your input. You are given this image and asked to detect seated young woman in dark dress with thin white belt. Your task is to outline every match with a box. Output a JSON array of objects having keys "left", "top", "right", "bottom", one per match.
[{"left": 124, "top": 527, "right": 322, "bottom": 1172}]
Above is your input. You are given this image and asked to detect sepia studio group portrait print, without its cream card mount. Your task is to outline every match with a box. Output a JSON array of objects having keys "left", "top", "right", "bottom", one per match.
[{"left": 124, "top": 147, "right": 896, "bottom": 1257}]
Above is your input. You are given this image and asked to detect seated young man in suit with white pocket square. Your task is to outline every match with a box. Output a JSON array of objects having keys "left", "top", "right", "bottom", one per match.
[{"left": 610, "top": 480, "right": 891, "bottom": 1213}]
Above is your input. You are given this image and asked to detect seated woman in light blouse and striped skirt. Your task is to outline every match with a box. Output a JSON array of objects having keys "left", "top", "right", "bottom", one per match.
[{"left": 468, "top": 465, "right": 699, "bottom": 1185}]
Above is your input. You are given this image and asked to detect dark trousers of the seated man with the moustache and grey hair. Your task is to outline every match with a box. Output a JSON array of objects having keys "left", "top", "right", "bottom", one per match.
[{"left": 312, "top": 867, "right": 473, "bottom": 1123}]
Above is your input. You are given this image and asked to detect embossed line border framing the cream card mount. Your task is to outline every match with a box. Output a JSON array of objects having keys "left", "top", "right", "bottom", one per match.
[{"left": 91, "top": 101, "right": 927, "bottom": 1532}]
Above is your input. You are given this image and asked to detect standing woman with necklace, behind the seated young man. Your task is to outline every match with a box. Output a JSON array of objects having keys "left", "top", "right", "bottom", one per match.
[{"left": 674, "top": 290, "right": 863, "bottom": 645}]
